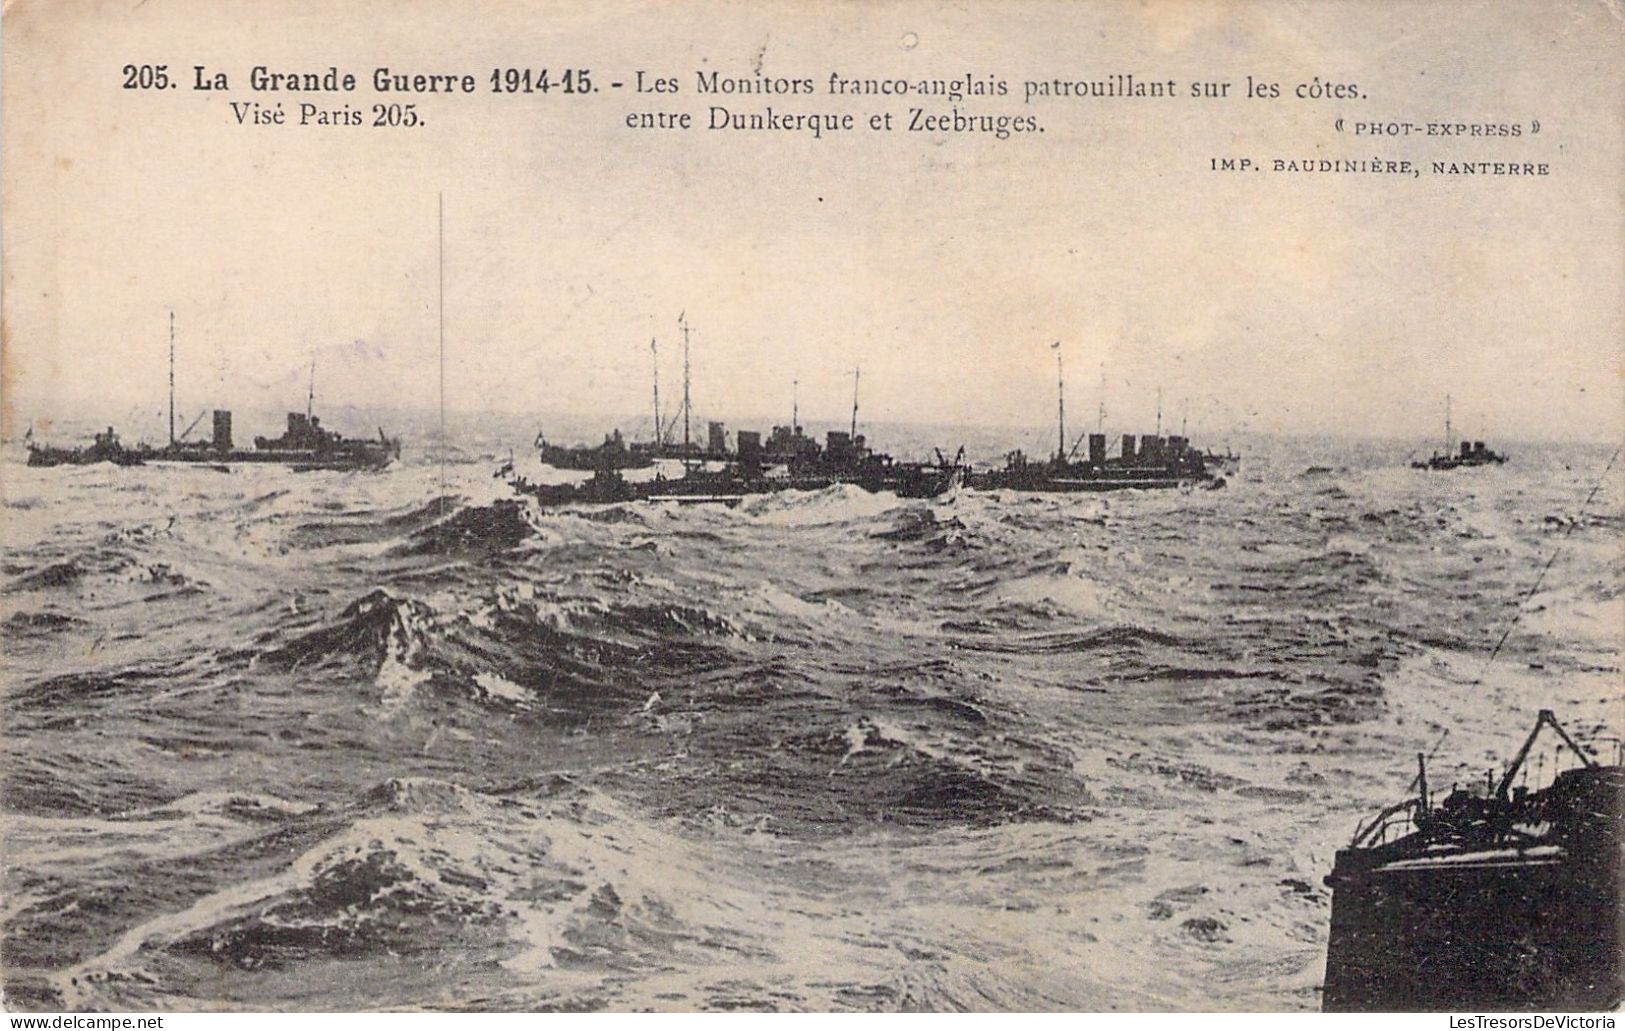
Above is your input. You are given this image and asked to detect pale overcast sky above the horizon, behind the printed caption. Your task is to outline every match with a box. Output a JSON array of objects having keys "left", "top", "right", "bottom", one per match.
[{"left": 3, "top": 0, "right": 1625, "bottom": 439}]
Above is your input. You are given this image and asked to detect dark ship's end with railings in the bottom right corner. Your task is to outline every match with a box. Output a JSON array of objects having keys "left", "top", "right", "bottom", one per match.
[{"left": 1323, "top": 709, "right": 1625, "bottom": 1011}]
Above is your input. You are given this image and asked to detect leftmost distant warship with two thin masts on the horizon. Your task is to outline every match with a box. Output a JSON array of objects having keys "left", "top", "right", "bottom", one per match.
[{"left": 28, "top": 312, "right": 401, "bottom": 472}]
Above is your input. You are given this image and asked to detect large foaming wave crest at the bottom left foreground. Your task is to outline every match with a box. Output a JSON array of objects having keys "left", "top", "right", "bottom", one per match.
[{"left": 52, "top": 777, "right": 783, "bottom": 1008}]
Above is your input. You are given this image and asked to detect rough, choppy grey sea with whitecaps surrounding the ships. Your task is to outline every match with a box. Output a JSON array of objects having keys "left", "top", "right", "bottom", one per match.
[{"left": 0, "top": 413, "right": 1625, "bottom": 1010}]
